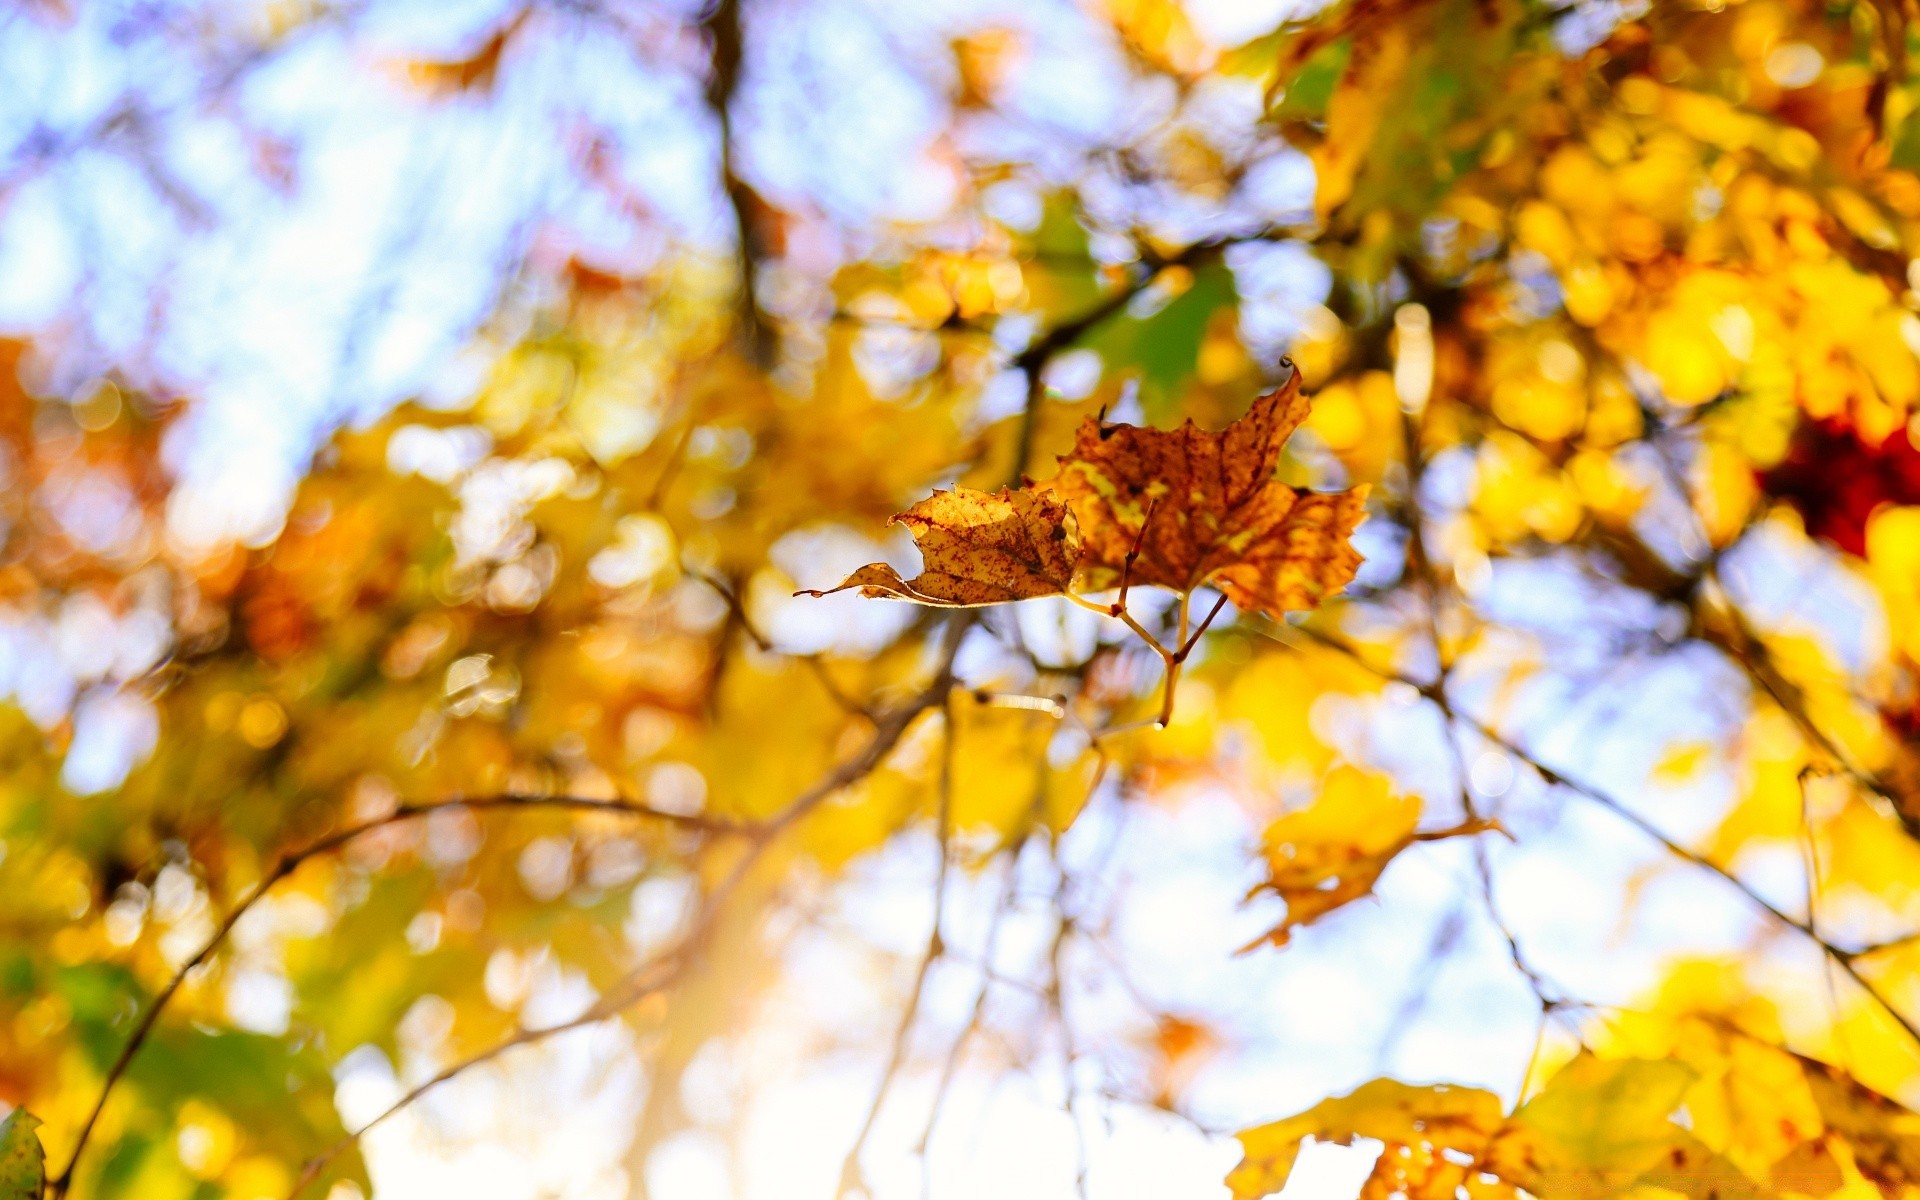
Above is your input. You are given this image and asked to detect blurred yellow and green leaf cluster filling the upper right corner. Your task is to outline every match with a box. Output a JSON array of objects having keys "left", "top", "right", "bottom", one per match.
[{"left": 1259, "top": 0, "right": 1920, "bottom": 583}]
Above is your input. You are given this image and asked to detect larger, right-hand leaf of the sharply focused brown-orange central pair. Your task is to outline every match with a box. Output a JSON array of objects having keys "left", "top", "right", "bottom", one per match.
[{"left": 1052, "top": 371, "right": 1367, "bottom": 618}]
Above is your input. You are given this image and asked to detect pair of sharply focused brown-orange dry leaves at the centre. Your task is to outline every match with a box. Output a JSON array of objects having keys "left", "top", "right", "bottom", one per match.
[{"left": 808, "top": 372, "right": 1367, "bottom": 618}]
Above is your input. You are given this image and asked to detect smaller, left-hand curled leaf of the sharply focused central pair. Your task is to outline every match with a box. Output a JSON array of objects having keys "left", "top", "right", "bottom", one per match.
[{"left": 795, "top": 488, "right": 1079, "bottom": 609}]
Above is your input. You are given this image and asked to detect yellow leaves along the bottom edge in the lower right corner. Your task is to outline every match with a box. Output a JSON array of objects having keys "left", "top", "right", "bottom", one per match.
[{"left": 1227, "top": 1043, "right": 1920, "bottom": 1200}]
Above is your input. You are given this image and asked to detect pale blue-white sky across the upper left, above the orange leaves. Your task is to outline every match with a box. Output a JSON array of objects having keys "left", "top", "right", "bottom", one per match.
[{"left": 0, "top": 0, "right": 1309, "bottom": 541}]
